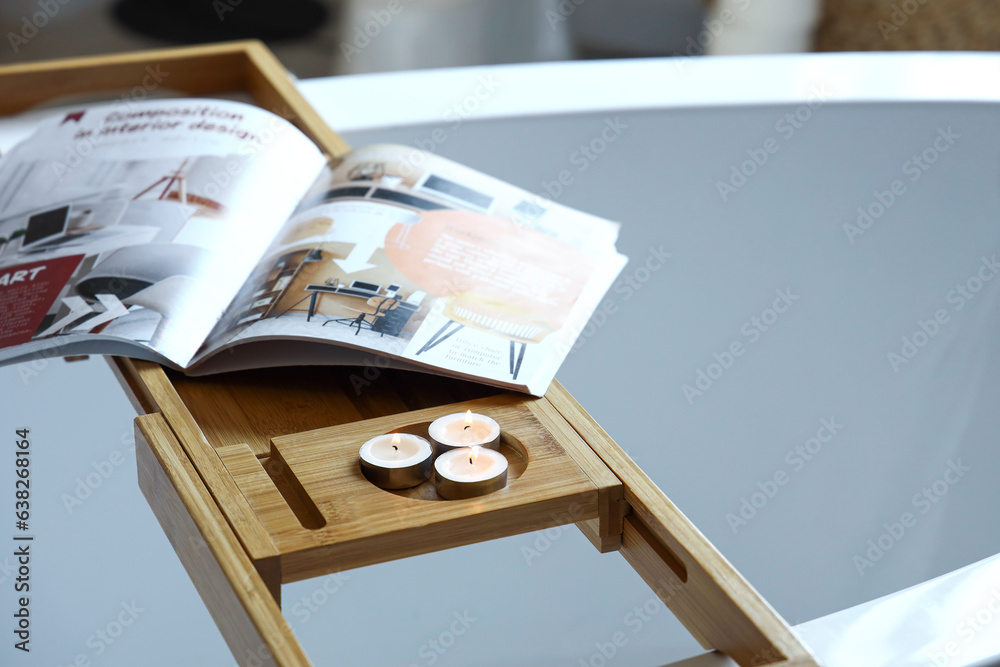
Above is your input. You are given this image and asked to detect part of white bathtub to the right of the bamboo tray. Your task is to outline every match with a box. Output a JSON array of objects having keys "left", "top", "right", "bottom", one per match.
[{"left": 303, "top": 54, "right": 1000, "bottom": 665}]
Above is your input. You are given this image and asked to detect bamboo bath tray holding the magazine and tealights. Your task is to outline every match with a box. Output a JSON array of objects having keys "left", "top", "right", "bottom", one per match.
[{"left": 0, "top": 42, "right": 817, "bottom": 667}]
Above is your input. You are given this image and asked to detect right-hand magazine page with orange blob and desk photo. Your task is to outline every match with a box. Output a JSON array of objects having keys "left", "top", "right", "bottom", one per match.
[{"left": 199, "top": 146, "right": 626, "bottom": 394}]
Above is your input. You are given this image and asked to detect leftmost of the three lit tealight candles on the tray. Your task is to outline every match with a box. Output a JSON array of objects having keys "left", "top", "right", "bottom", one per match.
[{"left": 360, "top": 433, "right": 434, "bottom": 489}]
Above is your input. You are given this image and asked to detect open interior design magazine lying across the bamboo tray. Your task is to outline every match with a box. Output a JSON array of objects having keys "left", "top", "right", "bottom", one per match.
[{"left": 0, "top": 99, "right": 626, "bottom": 395}]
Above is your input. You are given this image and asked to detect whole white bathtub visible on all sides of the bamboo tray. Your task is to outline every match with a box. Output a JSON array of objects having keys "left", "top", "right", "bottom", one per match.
[{"left": 0, "top": 56, "right": 1000, "bottom": 667}]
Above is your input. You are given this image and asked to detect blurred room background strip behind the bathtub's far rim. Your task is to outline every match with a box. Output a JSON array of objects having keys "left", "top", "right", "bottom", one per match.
[{"left": 0, "top": 0, "right": 1000, "bottom": 78}]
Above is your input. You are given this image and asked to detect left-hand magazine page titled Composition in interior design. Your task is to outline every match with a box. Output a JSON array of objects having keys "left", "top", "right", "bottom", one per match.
[{"left": 0, "top": 99, "right": 325, "bottom": 366}]
